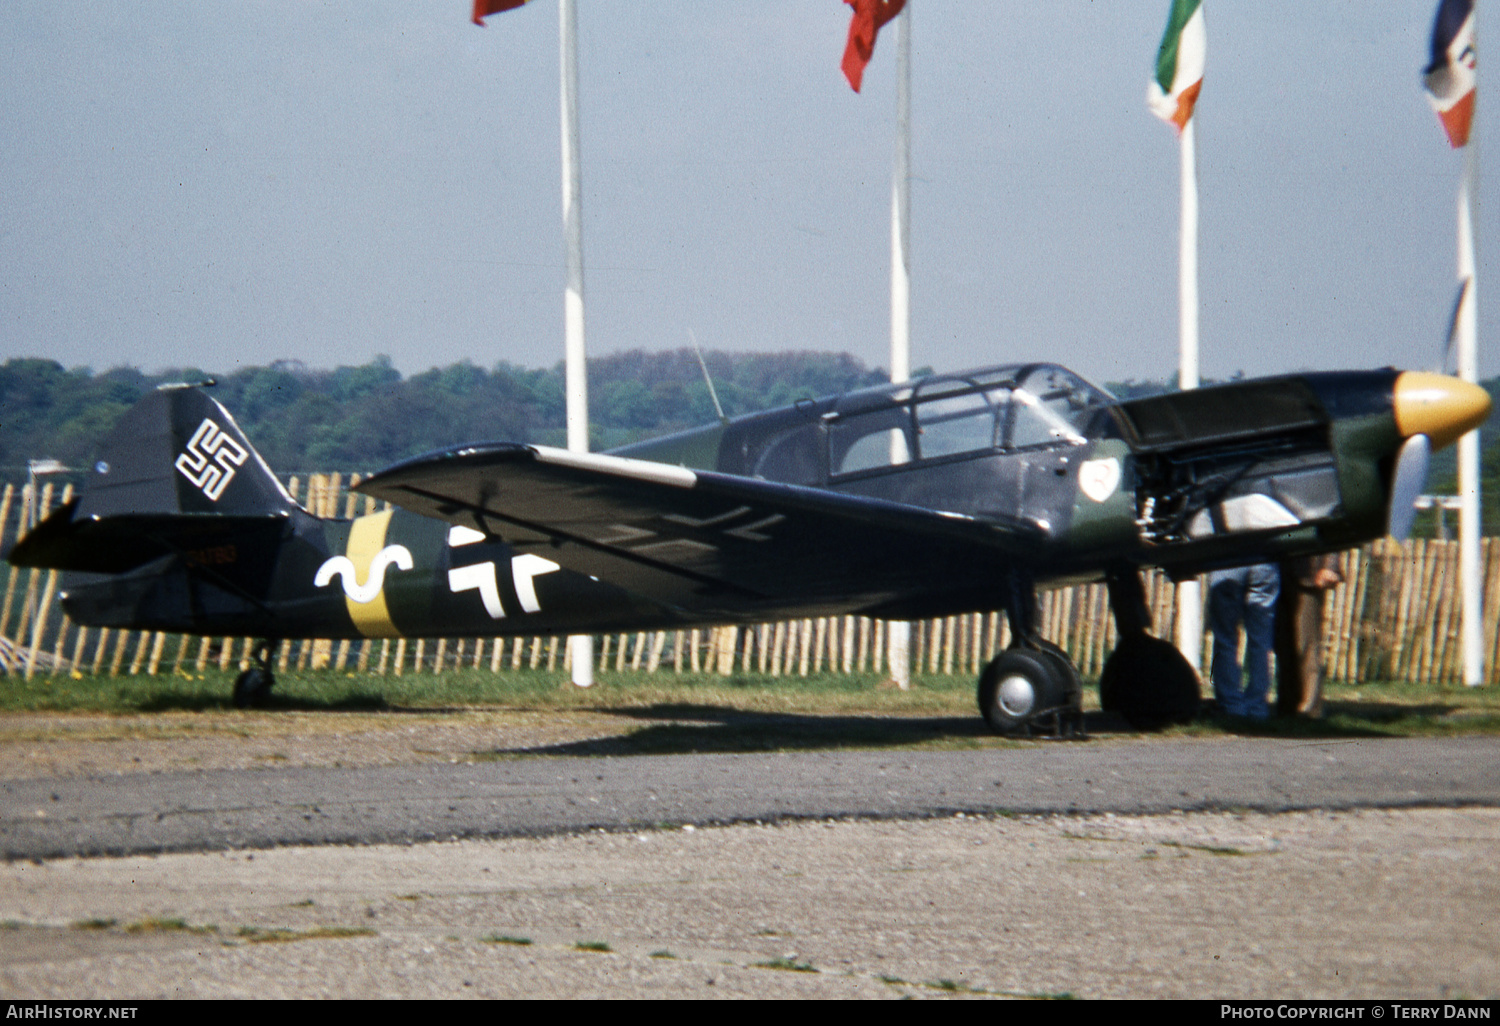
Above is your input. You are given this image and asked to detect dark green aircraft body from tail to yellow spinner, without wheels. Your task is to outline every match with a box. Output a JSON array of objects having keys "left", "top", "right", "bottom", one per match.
[{"left": 32, "top": 365, "right": 1488, "bottom": 638}]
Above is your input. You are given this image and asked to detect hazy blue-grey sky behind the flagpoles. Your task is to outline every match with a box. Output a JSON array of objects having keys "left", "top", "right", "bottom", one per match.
[{"left": 0, "top": 0, "right": 1500, "bottom": 381}]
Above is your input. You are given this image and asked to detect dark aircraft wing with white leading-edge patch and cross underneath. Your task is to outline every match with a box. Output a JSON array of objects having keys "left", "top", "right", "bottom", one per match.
[{"left": 359, "top": 444, "right": 1041, "bottom": 618}]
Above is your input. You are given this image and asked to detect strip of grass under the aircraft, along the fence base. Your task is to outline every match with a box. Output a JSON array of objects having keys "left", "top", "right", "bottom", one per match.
[{"left": 0, "top": 669, "right": 1500, "bottom": 758}]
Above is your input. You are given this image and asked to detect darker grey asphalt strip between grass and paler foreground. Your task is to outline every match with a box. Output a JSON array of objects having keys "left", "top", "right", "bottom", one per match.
[{"left": 0, "top": 737, "right": 1500, "bottom": 860}]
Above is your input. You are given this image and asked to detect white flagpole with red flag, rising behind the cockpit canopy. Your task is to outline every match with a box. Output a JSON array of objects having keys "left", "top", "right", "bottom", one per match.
[{"left": 887, "top": 2, "right": 912, "bottom": 692}]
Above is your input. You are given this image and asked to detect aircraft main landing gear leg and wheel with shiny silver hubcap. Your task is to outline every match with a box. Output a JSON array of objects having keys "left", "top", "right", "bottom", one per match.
[{"left": 978, "top": 578, "right": 1083, "bottom": 737}]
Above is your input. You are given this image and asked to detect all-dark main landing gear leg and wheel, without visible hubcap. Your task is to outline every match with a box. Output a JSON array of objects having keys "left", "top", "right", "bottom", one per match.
[{"left": 1100, "top": 570, "right": 1202, "bottom": 731}]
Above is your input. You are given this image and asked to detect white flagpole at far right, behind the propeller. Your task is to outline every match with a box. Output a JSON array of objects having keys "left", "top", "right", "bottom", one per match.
[{"left": 1455, "top": 134, "right": 1485, "bottom": 687}]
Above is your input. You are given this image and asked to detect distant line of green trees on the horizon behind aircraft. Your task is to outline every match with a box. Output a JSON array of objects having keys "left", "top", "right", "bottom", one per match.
[{"left": 0, "top": 350, "right": 1500, "bottom": 534}]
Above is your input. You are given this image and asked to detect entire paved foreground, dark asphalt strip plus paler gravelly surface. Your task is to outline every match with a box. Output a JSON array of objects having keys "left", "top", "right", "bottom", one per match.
[{"left": 0, "top": 726, "right": 1500, "bottom": 1001}]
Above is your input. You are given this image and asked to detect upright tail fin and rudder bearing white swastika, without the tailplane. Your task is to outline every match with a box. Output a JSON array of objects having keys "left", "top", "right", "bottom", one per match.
[{"left": 78, "top": 386, "right": 297, "bottom": 518}]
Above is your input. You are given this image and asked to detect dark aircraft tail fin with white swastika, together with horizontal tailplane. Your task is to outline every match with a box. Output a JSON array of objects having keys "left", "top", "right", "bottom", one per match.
[{"left": 5, "top": 387, "right": 300, "bottom": 573}]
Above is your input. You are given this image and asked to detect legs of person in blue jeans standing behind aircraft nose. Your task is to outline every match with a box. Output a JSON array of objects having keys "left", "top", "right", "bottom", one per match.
[{"left": 1209, "top": 563, "right": 1281, "bottom": 720}]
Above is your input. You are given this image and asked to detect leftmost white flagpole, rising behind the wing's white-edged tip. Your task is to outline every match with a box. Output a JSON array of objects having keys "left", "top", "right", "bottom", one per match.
[{"left": 558, "top": 0, "right": 594, "bottom": 687}]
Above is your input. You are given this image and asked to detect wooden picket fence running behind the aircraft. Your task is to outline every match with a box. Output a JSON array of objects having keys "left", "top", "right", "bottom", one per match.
[{"left": 0, "top": 474, "right": 1500, "bottom": 684}]
